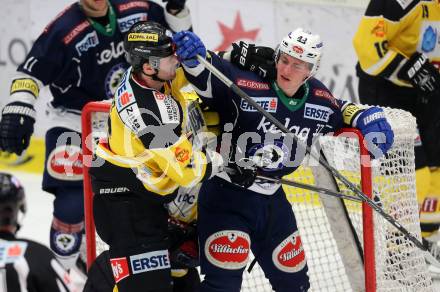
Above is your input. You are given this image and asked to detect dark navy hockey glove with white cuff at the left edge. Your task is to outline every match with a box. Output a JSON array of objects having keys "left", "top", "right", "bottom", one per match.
[{"left": 0, "top": 102, "right": 35, "bottom": 155}]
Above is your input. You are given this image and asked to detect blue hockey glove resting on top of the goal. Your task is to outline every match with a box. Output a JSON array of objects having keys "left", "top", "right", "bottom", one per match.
[{"left": 353, "top": 106, "right": 394, "bottom": 158}]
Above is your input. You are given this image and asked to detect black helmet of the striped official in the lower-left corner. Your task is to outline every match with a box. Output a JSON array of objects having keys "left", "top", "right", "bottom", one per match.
[{"left": 0, "top": 172, "right": 26, "bottom": 228}]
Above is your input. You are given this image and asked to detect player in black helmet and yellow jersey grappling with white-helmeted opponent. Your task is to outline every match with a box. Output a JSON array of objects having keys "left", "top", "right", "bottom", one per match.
[{"left": 90, "top": 22, "right": 222, "bottom": 292}]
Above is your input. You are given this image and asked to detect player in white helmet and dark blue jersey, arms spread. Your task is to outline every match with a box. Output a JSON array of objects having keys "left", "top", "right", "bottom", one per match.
[{"left": 174, "top": 29, "right": 394, "bottom": 292}]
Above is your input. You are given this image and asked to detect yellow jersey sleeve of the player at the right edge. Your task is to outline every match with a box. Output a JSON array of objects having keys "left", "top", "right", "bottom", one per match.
[{"left": 353, "top": 0, "right": 422, "bottom": 86}]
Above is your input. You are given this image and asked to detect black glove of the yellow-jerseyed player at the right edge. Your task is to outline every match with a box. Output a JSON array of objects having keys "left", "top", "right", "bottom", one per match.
[{"left": 397, "top": 52, "right": 440, "bottom": 94}]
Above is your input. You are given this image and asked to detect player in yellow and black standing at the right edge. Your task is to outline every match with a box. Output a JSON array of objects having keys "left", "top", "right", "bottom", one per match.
[{"left": 354, "top": 0, "right": 440, "bottom": 260}]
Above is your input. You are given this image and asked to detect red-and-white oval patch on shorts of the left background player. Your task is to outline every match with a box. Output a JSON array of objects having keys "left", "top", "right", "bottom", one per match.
[{"left": 46, "top": 145, "right": 83, "bottom": 181}]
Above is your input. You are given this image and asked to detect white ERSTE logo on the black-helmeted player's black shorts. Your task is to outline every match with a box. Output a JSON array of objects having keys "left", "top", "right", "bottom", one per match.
[{"left": 130, "top": 250, "right": 171, "bottom": 274}]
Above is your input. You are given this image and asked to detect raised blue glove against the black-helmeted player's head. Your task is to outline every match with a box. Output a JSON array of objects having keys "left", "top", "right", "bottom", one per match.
[{"left": 173, "top": 30, "right": 206, "bottom": 68}]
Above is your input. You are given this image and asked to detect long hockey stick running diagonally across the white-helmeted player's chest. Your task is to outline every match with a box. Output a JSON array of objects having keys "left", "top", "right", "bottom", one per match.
[{"left": 197, "top": 55, "right": 440, "bottom": 268}]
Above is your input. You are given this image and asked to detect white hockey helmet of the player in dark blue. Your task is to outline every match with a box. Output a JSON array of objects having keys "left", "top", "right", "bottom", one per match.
[{"left": 275, "top": 28, "right": 322, "bottom": 77}]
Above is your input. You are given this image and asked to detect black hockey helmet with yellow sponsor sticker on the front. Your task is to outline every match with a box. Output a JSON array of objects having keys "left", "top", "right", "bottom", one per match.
[{"left": 124, "top": 21, "right": 175, "bottom": 72}]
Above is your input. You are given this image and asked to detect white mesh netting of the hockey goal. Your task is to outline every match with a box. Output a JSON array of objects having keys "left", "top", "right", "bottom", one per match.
[{"left": 83, "top": 104, "right": 434, "bottom": 292}]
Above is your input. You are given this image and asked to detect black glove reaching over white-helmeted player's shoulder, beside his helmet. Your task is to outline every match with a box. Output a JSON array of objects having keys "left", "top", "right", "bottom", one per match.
[{"left": 231, "top": 41, "right": 277, "bottom": 80}]
